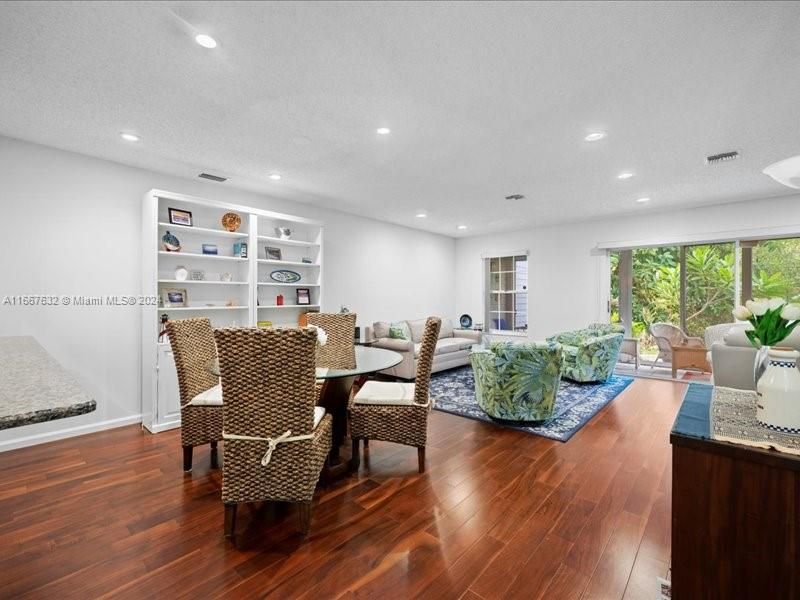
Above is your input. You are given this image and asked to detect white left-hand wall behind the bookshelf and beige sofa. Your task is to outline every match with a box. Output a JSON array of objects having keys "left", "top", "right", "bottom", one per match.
[{"left": 0, "top": 136, "right": 455, "bottom": 450}]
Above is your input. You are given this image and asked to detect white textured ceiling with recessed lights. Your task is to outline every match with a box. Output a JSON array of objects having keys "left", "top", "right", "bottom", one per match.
[{"left": 0, "top": 2, "right": 800, "bottom": 236}]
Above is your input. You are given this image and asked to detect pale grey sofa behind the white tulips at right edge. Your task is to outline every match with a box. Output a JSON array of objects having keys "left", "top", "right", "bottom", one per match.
[{"left": 711, "top": 323, "right": 800, "bottom": 390}]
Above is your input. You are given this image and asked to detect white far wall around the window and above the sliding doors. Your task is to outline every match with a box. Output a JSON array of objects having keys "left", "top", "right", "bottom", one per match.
[{"left": 455, "top": 195, "right": 800, "bottom": 339}]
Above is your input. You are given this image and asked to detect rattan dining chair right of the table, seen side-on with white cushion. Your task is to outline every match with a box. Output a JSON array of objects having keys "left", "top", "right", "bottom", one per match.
[{"left": 349, "top": 317, "right": 442, "bottom": 473}]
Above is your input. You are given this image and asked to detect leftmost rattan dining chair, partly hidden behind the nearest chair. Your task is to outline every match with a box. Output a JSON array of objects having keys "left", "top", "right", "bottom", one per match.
[{"left": 166, "top": 318, "right": 222, "bottom": 472}]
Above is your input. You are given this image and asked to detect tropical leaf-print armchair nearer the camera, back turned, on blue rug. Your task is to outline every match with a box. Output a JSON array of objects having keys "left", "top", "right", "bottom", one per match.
[{"left": 470, "top": 342, "right": 562, "bottom": 421}]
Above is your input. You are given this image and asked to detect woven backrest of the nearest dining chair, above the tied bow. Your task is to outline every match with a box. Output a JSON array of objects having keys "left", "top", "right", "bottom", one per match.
[{"left": 214, "top": 328, "right": 317, "bottom": 438}]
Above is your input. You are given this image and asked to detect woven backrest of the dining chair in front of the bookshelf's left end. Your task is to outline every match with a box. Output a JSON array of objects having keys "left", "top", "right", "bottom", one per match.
[{"left": 166, "top": 318, "right": 218, "bottom": 406}]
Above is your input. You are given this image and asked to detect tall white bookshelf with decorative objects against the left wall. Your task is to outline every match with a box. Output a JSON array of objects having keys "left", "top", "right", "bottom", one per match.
[{"left": 141, "top": 190, "right": 323, "bottom": 432}]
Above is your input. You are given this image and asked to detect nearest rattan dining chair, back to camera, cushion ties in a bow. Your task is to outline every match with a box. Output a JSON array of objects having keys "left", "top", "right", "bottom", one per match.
[{"left": 214, "top": 328, "right": 331, "bottom": 537}]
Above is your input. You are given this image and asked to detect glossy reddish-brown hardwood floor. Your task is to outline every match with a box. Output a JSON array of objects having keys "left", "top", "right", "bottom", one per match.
[{"left": 0, "top": 380, "right": 685, "bottom": 600}]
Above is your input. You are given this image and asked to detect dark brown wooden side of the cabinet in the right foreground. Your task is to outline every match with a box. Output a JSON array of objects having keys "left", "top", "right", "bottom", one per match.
[{"left": 671, "top": 428, "right": 800, "bottom": 600}]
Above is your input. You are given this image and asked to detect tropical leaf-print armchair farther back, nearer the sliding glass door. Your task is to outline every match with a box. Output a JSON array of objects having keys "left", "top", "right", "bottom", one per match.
[{"left": 547, "top": 323, "right": 625, "bottom": 382}]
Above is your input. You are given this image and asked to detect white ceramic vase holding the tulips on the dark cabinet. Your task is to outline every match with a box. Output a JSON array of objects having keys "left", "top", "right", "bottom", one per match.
[{"left": 756, "top": 347, "right": 800, "bottom": 434}]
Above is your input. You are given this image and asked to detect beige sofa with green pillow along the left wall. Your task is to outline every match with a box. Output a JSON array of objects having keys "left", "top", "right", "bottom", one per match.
[{"left": 366, "top": 319, "right": 483, "bottom": 379}]
